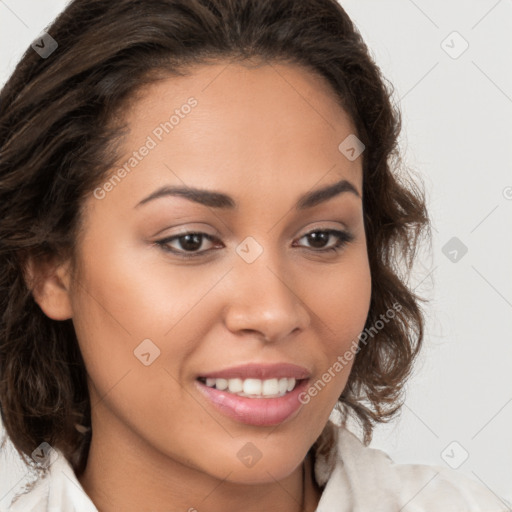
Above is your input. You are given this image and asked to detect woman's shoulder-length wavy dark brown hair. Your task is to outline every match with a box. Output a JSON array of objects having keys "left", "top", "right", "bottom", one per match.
[{"left": 0, "top": 0, "right": 430, "bottom": 474}]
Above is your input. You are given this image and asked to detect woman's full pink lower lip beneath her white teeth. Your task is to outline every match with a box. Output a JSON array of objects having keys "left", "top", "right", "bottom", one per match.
[{"left": 196, "top": 379, "right": 309, "bottom": 426}]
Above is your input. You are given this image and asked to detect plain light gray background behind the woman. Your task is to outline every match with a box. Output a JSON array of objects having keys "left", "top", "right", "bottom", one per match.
[{"left": 0, "top": 0, "right": 512, "bottom": 505}]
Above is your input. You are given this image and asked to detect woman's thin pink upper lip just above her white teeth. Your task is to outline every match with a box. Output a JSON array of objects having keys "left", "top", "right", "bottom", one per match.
[{"left": 199, "top": 363, "right": 311, "bottom": 380}]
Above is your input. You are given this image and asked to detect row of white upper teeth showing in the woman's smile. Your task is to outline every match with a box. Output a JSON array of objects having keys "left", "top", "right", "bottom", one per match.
[{"left": 206, "top": 377, "right": 296, "bottom": 398}]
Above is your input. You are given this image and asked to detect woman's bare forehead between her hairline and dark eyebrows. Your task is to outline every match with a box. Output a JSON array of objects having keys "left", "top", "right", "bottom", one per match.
[{"left": 102, "top": 62, "right": 362, "bottom": 206}]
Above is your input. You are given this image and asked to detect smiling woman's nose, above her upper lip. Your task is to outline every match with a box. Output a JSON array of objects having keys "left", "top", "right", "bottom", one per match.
[{"left": 224, "top": 252, "right": 311, "bottom": 342}]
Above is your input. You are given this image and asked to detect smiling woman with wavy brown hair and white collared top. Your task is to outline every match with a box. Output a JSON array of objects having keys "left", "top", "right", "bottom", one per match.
[{"left": 0, "top": 0, "right": 503, "bottom": 512}]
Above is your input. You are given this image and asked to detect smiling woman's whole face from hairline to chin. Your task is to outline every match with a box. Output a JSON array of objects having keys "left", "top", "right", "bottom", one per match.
[{"left": 64, "top": 62, "right": 371, "bottom": 483}]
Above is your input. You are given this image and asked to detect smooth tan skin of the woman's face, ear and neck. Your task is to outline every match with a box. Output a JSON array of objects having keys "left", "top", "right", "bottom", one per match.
[{"left": 28, "top": 61, "right": 371, "bottom": 512}]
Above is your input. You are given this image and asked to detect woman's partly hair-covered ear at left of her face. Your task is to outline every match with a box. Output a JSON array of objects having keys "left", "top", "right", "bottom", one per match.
[{"left": 24, "top": 253, "right": 73, "bottom": 320}]
